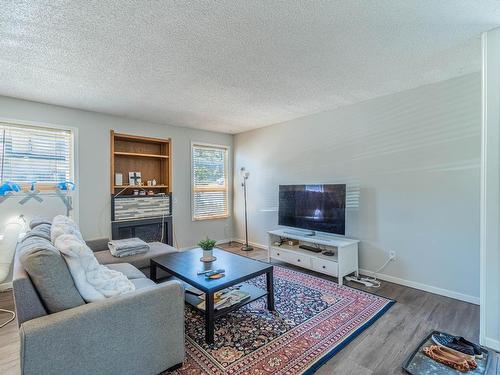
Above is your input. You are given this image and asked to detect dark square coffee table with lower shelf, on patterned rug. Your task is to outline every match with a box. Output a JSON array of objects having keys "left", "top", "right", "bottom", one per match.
[{"left": 150, "top": 248, "right": 274, "bottom": 343}]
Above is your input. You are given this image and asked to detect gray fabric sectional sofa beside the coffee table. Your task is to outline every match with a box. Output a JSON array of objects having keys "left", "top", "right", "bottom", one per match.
[{"left": 13, "top": 224, "right": 185, "bottom": 375}]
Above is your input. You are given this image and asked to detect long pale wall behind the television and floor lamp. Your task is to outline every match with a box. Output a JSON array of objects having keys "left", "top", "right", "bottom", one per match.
[{"left": 234, "top": 74, "right": 481, "bottom": 303}]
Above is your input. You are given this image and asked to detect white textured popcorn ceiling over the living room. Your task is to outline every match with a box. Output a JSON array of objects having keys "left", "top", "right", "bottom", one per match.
[{"left": 0, "top": 0, "right": 500, "bottom": 133}]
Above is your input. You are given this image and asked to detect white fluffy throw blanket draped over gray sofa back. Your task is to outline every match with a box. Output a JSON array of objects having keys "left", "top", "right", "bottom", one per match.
[{"left": 51, "top": 216, "right": 135, "bottom": 302}]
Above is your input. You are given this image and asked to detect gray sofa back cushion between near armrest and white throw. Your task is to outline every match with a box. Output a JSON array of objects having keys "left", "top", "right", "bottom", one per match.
[{"left": 18, "top": 236, "right": 85, "bottom": 313}]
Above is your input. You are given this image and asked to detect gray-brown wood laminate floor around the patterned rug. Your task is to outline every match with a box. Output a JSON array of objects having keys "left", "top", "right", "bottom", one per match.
[{"left": 0, "top": 243, "right": 497, "bottom": 375}]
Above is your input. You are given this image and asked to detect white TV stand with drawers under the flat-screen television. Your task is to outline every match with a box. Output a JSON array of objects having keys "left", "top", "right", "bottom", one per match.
[{"left": 267, "top": 229, "right": 359, "bottom": 285}]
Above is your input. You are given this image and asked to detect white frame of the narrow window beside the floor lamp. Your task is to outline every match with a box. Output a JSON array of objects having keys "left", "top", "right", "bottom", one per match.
[{"left": 189, "top": 141, "right": 231, "bottom": 221}]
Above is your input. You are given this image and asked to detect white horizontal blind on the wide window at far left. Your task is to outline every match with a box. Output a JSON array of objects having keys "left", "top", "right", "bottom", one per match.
[{"left": 0, "top": 123, "right": 73, "bottom": 184}]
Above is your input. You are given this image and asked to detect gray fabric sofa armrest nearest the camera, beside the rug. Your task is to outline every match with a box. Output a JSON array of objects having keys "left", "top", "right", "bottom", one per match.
[{"left": 20, "top": 281, "right": 185, "bottom": 375}]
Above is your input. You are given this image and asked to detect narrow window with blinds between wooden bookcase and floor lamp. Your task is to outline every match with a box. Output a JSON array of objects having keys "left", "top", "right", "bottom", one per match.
[{"left": 192, "top": 144, "right": 229, "bottom": 220}]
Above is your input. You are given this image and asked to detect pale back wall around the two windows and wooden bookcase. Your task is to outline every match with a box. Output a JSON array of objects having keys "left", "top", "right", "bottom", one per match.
[{"left": 0, "top": 97, "right": 233, "bottom": 247}]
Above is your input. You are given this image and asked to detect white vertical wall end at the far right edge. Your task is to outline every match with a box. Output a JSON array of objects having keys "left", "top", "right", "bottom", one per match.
[{"left": 480, "top": 29, "right": 500, "bottom": 351}]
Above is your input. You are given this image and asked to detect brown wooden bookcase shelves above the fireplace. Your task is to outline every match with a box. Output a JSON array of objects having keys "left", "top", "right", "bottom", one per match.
[{"left": 110, "top": 130, "right": 172, "bottom": 195}]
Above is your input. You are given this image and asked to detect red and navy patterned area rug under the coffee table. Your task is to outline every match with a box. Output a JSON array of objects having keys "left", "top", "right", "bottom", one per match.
[{"left": 164, "top": 266, "right": 394, "bottom": 375}]
